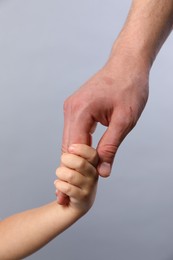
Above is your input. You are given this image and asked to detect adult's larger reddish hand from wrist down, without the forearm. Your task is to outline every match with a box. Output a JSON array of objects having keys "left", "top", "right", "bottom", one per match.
[{"left": 62, "top": 54, "right": 148, "bottom": 177}]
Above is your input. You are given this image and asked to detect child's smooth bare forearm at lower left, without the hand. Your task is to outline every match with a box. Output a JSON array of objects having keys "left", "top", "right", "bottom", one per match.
[{"left": 0, "top": 202, "right": 80, "bottom": 260}]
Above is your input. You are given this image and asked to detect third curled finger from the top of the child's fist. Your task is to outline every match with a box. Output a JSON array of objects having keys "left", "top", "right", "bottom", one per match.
[{"left": 56, "top": 167, "right": 86, "bottom": 188}]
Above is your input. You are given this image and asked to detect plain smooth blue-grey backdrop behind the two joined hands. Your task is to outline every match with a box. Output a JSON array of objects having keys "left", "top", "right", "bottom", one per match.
[{"left": 0, "top": 0, "right": 173, "bottom": 260}]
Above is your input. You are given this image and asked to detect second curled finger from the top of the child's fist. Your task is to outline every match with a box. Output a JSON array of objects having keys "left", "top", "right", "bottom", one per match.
[{"left": 61, "top": 153, "right": 98, "bottom": 177}]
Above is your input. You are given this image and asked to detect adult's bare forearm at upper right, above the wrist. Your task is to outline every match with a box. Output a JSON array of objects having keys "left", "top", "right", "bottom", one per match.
[{"left": 111, "top": 0, "right": 173, "bottom": 70}]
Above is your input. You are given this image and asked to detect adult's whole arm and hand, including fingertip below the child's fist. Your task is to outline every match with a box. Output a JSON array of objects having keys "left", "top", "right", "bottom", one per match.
[{"left": 59, "top": 0, "right": 173, "bottom": 204}]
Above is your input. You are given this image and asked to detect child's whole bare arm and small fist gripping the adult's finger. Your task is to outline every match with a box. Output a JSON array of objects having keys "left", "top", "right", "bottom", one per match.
[{"left": 0, "top": 144, "right": 98, "bottom": 260}]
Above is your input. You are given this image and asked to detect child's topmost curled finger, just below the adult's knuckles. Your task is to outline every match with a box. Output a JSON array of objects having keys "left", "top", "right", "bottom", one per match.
[{"left": 68, "top": 144, "right": 99, "bottom": 167}]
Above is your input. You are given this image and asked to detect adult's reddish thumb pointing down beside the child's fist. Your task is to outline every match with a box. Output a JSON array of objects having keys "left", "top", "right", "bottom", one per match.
[{"left": 97, "top": 117, "right": 127, "bottom": 177}]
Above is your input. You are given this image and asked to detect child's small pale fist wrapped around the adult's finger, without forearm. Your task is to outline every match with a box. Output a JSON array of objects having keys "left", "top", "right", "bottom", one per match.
[{"left": 54, "top": 144, "right": 98, "bottom": 214}]
